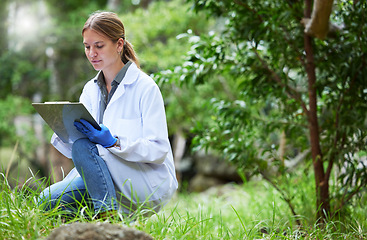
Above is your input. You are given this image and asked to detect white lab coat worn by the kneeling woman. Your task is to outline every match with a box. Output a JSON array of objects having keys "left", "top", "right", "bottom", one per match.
[{"left": 51, "top": 63, "right": 178, "bottom": 213}]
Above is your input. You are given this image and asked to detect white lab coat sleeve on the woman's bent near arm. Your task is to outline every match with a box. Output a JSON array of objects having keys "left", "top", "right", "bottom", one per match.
[{"left": 109, "top": 84, "right": 171, "bottom": 164}]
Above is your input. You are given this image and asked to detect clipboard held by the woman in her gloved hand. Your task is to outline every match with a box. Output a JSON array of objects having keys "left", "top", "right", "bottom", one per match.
[{"left": 32, "top": 102, "right": 101, "bottom": 143}]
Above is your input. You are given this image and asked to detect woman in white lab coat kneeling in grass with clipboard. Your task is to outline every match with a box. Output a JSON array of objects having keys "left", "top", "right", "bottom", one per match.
[{"left": 40, "top": 12, "right": 177, "bottom": 218}]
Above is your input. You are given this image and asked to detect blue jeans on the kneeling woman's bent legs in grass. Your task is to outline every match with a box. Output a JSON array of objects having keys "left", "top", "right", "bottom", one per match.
[{"left": 38, "top": 138, "right": 118, "bottom": 213}]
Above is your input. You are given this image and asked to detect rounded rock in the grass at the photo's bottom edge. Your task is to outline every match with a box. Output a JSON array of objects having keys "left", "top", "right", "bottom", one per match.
[{"left": 46, "top": 222, "right": 153, "bottom": 240}]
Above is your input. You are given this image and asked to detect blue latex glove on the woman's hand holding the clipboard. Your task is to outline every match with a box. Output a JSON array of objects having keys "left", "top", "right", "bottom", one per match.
[{"left": 74, "top": 119, "right": 117, "bottom": 148}]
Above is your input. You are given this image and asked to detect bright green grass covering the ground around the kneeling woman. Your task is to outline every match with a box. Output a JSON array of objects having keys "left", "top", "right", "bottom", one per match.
[{"left": 0, "top": 172, "right": 367, "bottom": 240}]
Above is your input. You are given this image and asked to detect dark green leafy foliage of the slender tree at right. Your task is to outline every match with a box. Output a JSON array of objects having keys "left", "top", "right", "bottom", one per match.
[{"left": 160, "top": 0, "right": 367, "bottom": 221}]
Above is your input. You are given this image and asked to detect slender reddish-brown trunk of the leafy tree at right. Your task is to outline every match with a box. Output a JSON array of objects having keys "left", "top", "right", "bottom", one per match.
[{"left": 304, "top": 0, "right": 330, "bottom": 222}]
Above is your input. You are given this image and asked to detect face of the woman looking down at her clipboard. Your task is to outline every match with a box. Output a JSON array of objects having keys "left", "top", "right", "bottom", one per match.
[{"left": 83, "top": 29, "right": 123, "bottom": 71}]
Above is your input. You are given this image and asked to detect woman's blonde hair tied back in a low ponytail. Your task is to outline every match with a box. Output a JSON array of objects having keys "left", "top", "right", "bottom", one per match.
[{"left": 82, "top": 11, "right": 140, "bottom": 67}]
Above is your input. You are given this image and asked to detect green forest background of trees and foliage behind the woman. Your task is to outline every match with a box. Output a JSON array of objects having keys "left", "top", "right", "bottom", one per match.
[{"left": 0, "top": 0, "right": 367, "bottom": 237}]
